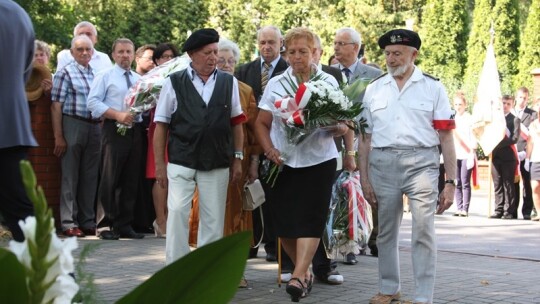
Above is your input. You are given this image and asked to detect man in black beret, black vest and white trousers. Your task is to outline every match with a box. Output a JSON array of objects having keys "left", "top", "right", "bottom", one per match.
[{"left": 154, "top": 29, "right": 247, "bottom": 264}]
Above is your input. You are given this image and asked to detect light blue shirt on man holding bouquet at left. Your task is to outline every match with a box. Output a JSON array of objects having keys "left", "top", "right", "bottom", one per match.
[{"left": 88, "top": 64, "right": 141, "bottom": 121}]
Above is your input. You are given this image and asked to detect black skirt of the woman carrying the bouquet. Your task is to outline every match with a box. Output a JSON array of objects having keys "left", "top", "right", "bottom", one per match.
[{"left": 268, "top": 158, "right": 337, "bottom": 238}]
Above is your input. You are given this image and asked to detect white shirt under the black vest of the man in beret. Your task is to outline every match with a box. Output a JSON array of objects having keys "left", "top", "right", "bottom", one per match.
[{"left": 154, "top": 65, "right": 242, "bottom": 124}]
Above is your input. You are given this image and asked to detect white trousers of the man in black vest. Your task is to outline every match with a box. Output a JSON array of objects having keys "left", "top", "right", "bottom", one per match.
[{"left": 165, "top": 163, "right": 229, "bottom": 265}]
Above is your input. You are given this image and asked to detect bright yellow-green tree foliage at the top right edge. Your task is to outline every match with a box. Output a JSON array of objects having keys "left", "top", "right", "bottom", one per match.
[{"left": 514, "top": 0, "right": 540, "bottom": 88}]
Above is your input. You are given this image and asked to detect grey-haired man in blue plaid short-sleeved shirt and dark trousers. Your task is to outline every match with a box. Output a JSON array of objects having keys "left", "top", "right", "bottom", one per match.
[{"left": 51, "top": 35, "right": 101, "bottom": 237}]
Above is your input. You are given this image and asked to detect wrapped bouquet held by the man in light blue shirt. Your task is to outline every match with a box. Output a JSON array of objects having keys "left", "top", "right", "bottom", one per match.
[{"left": 116, "top": 55, "right": 191, "bottom": 135}]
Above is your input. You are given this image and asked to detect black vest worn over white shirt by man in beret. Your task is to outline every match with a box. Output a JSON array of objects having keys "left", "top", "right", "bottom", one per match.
[{"left": 167, "top": 69, "right": 233, "bottom": 171}]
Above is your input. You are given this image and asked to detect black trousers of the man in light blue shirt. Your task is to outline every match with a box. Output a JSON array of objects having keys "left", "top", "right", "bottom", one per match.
[{"left": 97, "top": 119, "right": 142, "bottom": 230}]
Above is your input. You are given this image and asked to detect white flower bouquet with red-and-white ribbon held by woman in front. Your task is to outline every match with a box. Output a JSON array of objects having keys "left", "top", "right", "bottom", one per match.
[{"left": 266, "top": 74, "right": 364, "bottom": 185}]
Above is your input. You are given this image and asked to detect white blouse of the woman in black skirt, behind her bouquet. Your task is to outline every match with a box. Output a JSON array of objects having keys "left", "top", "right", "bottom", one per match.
[{"left": 259, "top": 67, "right": 339, "bottom": 168}]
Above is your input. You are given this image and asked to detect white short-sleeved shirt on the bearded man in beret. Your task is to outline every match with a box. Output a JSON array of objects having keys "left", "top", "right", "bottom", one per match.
[{"left": 362, "top": 66, "right": 453, "bottom": 148}]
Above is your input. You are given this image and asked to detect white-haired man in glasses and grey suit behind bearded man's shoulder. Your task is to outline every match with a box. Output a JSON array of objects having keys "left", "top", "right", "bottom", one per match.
[{"left": 332, "top": 27, "right": 381, "bottom": 88}]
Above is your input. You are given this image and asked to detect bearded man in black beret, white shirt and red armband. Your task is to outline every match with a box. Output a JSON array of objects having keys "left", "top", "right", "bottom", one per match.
[{"left": 358, "top": 29, "right": 456, "bottom": 304}]
